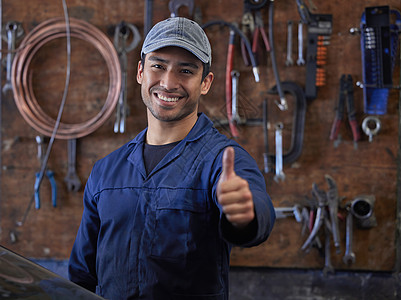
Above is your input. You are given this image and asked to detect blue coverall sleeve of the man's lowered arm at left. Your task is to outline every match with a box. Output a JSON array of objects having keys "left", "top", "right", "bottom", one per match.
[{"left": 68, "top": 172, "right": 100, "bottom": 292}]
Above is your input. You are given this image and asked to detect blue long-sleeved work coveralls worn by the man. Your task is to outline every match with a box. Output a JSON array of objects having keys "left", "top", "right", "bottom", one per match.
[{"left": 69, "top": 113, "right": 275, "bottom": 300}]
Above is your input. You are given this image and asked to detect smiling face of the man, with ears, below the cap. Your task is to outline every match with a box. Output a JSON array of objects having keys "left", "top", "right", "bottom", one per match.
[{"left": 137, "top": 47, "right": 213, "bottom": 122}]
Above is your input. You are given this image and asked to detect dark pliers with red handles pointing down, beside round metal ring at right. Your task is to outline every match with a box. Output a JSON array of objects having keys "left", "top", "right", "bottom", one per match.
[{"left": 330, "top": 74, "right": 361, "bottom": 147}]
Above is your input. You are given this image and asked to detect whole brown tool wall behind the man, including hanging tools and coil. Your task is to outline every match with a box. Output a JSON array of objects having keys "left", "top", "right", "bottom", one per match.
[{"left": 0, "top": 0, "right": 401, "bottom": 273}]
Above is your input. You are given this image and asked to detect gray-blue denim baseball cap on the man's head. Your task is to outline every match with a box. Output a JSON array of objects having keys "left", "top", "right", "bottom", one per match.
[{"left": 141, "top": 17, "right": 212, "bottom": 65}]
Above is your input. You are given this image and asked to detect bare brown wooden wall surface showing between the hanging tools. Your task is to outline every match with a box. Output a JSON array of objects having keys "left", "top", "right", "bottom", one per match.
[{"left": 0, "top": 0, "right": 401, "bottom": 271}]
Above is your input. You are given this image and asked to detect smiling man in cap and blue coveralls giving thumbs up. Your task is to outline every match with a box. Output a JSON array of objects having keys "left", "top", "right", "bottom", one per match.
[{"left": 69, "top": 18, "right": 275, "bottom": 300}]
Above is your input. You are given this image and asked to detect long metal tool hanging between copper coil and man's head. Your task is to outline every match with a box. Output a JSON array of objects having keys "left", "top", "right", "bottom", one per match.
[{"left": 114, "top": 21, "right": 141, "bottom": 133}]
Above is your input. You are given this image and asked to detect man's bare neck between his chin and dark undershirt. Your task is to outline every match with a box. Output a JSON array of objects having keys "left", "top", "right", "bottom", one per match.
[{"left": 146, "top": 111, "right": 198, "bottom": 145}]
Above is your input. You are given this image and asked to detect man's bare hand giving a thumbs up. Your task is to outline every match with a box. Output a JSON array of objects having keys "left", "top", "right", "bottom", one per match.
[{"left": 217, "top": 147, "right": 255, "bottom": 228}]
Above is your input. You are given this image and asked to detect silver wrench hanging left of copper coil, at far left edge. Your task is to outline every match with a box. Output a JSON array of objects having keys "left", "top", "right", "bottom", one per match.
[{"left": 2, "top": 21, "right": 24, "bottom": 94}]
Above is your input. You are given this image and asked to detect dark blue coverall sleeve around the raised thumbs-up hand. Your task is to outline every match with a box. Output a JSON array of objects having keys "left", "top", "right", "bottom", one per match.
[{"left": 214, "top": 147, "right": 276, "bottom": 247}]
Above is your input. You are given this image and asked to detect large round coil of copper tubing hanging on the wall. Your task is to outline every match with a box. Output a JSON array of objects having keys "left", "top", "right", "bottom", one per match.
[{"left": 11, "top": 18, "right": 121, "bottom": 139}]
